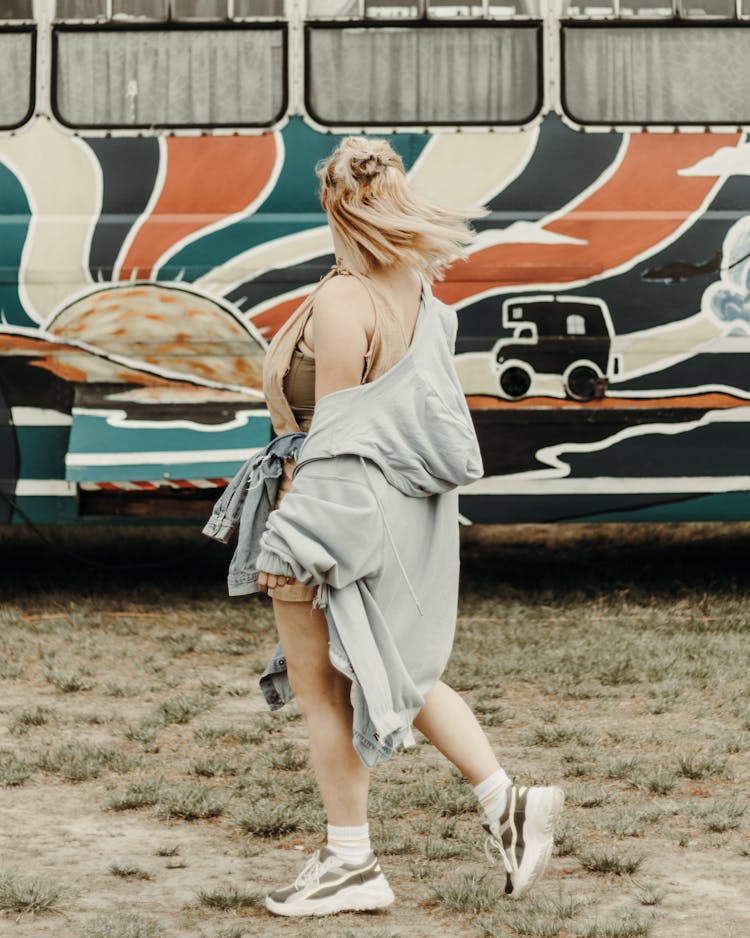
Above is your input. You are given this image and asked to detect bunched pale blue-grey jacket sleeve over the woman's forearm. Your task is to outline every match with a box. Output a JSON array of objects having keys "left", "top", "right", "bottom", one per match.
[{"left": 256, "top": 456, "right": 383, "bottom": 589}]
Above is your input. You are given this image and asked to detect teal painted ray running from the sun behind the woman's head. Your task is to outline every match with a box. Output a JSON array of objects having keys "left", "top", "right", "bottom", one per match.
[{"left": 157, "top": 117, "right": 430, "bottom": 282}]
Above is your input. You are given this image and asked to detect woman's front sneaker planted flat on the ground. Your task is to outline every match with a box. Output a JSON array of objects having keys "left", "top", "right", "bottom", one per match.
[{"left": 266, "top": 847, "right": 394, "bottom": 916}]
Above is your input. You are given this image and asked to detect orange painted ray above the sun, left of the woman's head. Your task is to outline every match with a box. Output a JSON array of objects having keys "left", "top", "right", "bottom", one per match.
[{"left": 120, "top": 134, "right": 276, "bottom": 280}]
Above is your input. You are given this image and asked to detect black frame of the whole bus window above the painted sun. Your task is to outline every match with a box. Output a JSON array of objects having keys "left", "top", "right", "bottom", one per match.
[{"left": 50, "top": 20, "right": 289, "bottom": 133}]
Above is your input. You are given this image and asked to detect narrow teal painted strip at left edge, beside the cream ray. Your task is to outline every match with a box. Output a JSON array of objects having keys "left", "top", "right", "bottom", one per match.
[{"left": 0, "top": 162, "right": 36, "bottom": 329}]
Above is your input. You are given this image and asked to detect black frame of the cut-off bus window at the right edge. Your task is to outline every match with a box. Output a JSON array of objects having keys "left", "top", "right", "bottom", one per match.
[{"left": 558, "top": 17, "right": 750, "bottom": 132}]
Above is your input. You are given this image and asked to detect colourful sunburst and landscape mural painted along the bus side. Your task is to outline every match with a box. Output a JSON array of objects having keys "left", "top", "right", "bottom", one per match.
[{"left": 0, "top": 3, "right": 750, "bottom": 523}]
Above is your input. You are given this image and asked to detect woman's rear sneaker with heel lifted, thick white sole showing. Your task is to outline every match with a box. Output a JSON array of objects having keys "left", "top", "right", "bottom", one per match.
[{"left": 484, "top": 785, "right": 565, "bottom": 899}]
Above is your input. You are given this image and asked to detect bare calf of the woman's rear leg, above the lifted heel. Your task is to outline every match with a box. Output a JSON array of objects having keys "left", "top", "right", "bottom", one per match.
[{"left": 414, "top": 681, "right": 500, "bottom": 785}]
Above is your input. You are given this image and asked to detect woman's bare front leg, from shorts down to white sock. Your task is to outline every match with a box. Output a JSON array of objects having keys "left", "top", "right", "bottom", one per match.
[{"left": 273, "top": 599, "right": 370, "bottom": 827}]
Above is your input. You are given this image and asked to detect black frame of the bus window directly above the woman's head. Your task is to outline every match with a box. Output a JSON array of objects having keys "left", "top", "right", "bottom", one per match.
[{"left": 303, "top": 18, "right": 545, "bottom": 133}]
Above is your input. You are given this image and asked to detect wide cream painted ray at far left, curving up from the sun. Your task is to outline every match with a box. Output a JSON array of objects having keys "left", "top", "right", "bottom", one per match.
[{"left": 0, "top": 120, "right": 102, "bottom": 322}]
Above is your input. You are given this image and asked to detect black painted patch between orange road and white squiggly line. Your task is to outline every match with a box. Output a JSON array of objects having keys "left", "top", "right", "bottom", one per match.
[{"left": 472, "top": 406, "right": 705, "bottom": 476}]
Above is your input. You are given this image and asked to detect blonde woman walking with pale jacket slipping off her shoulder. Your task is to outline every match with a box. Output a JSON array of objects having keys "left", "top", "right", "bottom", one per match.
[{"left": 257, "top": 137, "right": 563, "bottom": 916}]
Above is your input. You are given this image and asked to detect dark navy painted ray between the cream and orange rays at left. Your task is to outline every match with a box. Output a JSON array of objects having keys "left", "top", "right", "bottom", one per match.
[{"left": 86, "top": 137, "right": 159, "bottom": 280}]
